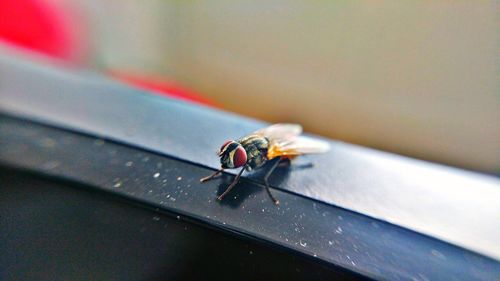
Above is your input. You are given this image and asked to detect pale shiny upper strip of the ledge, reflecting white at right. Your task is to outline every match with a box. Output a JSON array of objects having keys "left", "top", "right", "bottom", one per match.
[{"left": 0, "top": 53, "right": 500, "bottom": 259}]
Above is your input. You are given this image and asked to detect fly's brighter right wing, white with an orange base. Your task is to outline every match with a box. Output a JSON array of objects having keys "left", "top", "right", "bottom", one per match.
[{"left": 267, "top": 136, "right": 330, "bottom": 159}]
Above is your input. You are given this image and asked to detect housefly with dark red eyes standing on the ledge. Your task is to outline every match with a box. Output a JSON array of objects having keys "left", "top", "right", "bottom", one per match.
[{"left": 200, "top": 124, "right": 330, "bottom": 204}]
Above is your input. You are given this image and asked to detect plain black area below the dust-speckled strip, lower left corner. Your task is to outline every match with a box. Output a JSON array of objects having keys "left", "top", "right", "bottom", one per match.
[{"left": 0, "top": 169, "right": 362, "bottom": 281}]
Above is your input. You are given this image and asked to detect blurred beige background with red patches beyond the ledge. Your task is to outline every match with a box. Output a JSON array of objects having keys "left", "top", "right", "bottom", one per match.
[{"left": 0, "top": 0, "right": 500, "bottom": 174}]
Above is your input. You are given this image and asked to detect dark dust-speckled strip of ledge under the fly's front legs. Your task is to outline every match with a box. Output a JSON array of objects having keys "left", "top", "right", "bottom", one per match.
[{"left": 0, "top": 116, "right": 500, "bottom": 280}]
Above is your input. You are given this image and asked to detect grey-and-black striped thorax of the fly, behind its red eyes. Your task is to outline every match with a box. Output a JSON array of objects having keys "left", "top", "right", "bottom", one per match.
[{"left": 238, "top": 135, "right": 269, "bottom": 169}]
